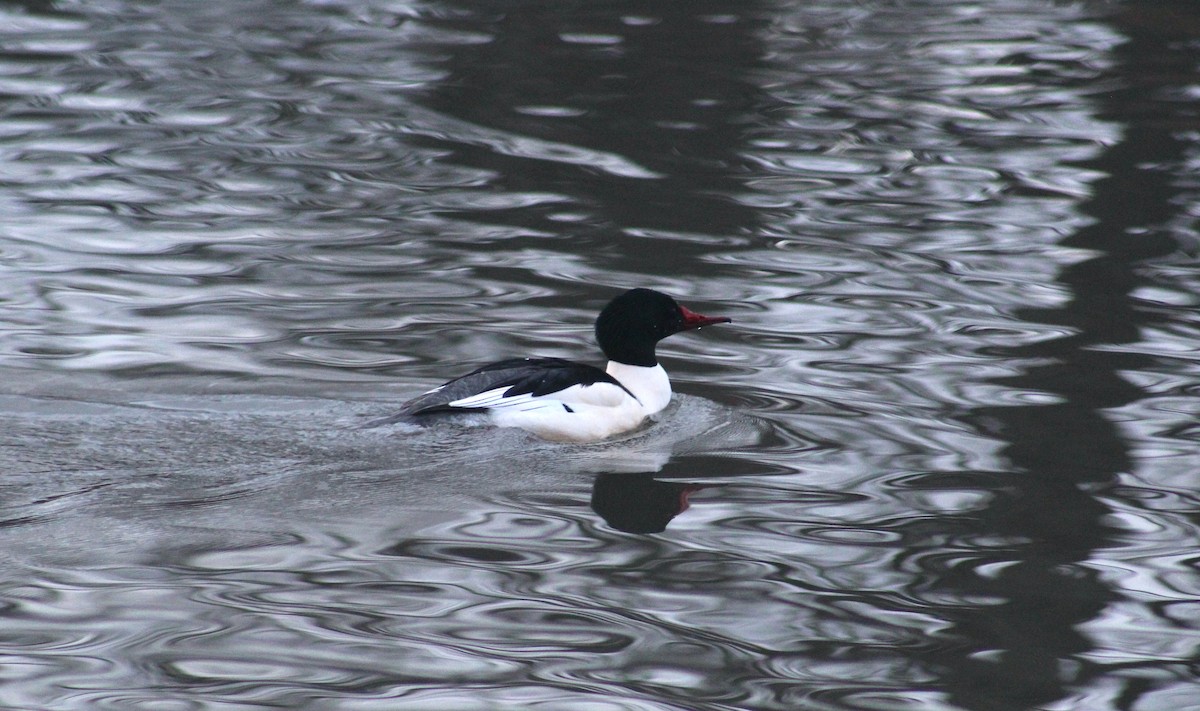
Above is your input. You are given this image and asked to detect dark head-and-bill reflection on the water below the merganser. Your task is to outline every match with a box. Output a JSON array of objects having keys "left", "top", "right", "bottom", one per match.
[{"left": 592, "top": 474, "right": 719, "bottom": 533}]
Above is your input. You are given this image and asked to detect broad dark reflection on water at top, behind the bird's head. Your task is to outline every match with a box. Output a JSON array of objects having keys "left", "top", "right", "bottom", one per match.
[{"left": 420, "top": 0, "right": 769, "bottom": 241}]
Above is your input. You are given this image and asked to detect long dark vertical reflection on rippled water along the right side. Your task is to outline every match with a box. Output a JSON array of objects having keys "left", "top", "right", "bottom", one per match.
[{"left": 920, "top": 4, "right": 1200, "bottom": 709}]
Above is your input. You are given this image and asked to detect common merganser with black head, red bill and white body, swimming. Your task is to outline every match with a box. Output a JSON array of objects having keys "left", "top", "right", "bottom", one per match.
[{"left": 401, "top": 288, "right": 731, "bottom": 442}]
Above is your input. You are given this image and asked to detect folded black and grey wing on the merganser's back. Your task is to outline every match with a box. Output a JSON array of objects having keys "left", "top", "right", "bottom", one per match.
[{"left": 401, "top": 358, "right": 632, "bottom": 414}]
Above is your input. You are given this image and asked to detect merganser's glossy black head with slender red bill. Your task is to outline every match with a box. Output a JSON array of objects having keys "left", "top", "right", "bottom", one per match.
[{"left": 596, "top": 288, "right": 731, "bottom": 368}]
